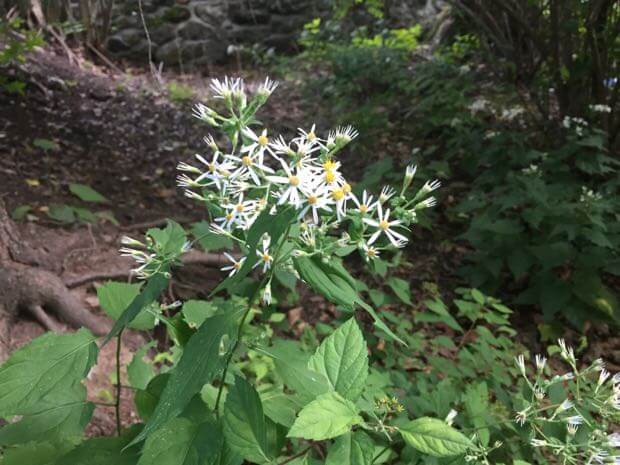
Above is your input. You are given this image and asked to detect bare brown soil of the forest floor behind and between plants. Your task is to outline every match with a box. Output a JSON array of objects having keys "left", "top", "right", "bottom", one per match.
[{"left": 0, "top": 46, "right": 618, "bottom": 435}]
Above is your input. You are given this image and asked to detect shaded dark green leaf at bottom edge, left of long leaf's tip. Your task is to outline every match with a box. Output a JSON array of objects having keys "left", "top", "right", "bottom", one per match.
[{"left": 54, "top": 426, "right": 140, "bottom": 465}]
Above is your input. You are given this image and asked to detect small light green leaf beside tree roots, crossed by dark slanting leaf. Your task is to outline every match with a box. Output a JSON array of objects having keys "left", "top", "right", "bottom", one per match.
[{"left": 97, "top": 281, "right": 155, "bottom": 330}]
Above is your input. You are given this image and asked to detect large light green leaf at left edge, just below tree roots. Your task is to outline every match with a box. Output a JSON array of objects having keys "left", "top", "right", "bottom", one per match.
[{"left": 0, "top": 329, "right": 97, "bottom": 417}]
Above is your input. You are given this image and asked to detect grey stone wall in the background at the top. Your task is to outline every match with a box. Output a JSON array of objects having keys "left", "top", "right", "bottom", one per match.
[{"left": 107, "top": 0, "right": 328, "bottom": 66}]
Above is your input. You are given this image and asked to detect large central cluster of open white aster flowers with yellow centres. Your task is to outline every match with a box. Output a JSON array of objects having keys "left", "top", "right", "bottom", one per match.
[{"left": 177, "top": 78, "right": 440, "bottom": 284}]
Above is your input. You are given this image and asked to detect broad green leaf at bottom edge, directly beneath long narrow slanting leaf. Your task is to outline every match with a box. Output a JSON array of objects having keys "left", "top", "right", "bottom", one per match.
[{"left": 138, "top": 418, "right": 223, "bottom": 465}]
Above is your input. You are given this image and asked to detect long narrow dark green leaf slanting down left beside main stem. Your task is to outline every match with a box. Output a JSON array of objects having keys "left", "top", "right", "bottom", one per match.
[{"left": 132, "top": 308, "right": 244, "bottom": 444}]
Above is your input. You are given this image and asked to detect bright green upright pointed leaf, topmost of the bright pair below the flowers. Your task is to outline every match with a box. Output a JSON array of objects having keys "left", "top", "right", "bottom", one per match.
[{"left": 308, "top": 318, "right": 368, "bottom": 401}]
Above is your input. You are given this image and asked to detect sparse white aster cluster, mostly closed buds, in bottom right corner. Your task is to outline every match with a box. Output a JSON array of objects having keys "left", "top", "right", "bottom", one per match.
[{"left": 515, "top": 339, "right": 620, "bottom": 465}]
